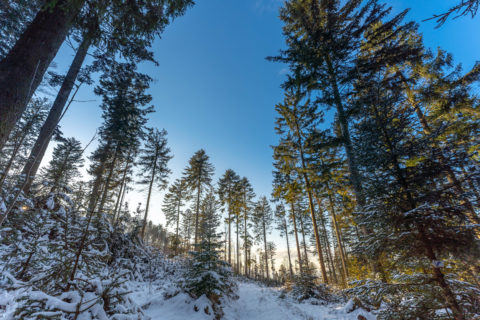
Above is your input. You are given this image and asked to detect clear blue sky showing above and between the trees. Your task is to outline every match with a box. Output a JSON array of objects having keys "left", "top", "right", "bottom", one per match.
[{"left": 46, "top": 0, "right": 480, "bottom": 258}]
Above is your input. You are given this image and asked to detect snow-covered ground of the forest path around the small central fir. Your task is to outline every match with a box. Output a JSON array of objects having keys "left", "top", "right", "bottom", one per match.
[{"left": 133, "top": 282, "right": 375, "bottom": 320}]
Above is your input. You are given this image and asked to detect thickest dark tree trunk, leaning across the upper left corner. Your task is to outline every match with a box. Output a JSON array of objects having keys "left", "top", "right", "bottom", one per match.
[{"left": 0, "top": 0, "right": 85, "bottom": 150}]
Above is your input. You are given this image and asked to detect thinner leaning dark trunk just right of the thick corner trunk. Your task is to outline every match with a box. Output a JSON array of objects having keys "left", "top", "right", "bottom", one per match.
[{"left": 22, "top": 37, "right": 91, "bottom": 192}]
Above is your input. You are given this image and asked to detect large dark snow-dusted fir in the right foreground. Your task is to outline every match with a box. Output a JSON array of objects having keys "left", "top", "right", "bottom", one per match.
[{"left": 348, "top": 27, "right": 478, "bottom": 319}]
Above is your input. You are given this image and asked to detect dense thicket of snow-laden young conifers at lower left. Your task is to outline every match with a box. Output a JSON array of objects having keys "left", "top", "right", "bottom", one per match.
[{"left": 0, "top": 188, "right": 171, "bottom": 320}]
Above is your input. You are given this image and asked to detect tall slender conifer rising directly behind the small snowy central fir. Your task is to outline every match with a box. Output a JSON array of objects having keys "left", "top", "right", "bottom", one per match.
[{"left": 183, "top": 149, "right": 214, "bottom": 245}]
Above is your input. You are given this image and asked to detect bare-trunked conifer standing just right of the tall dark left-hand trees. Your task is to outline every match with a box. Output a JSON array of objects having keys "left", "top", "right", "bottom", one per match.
[{"left": 138, "top": 129, "right": 173, "bottom": 239}]
